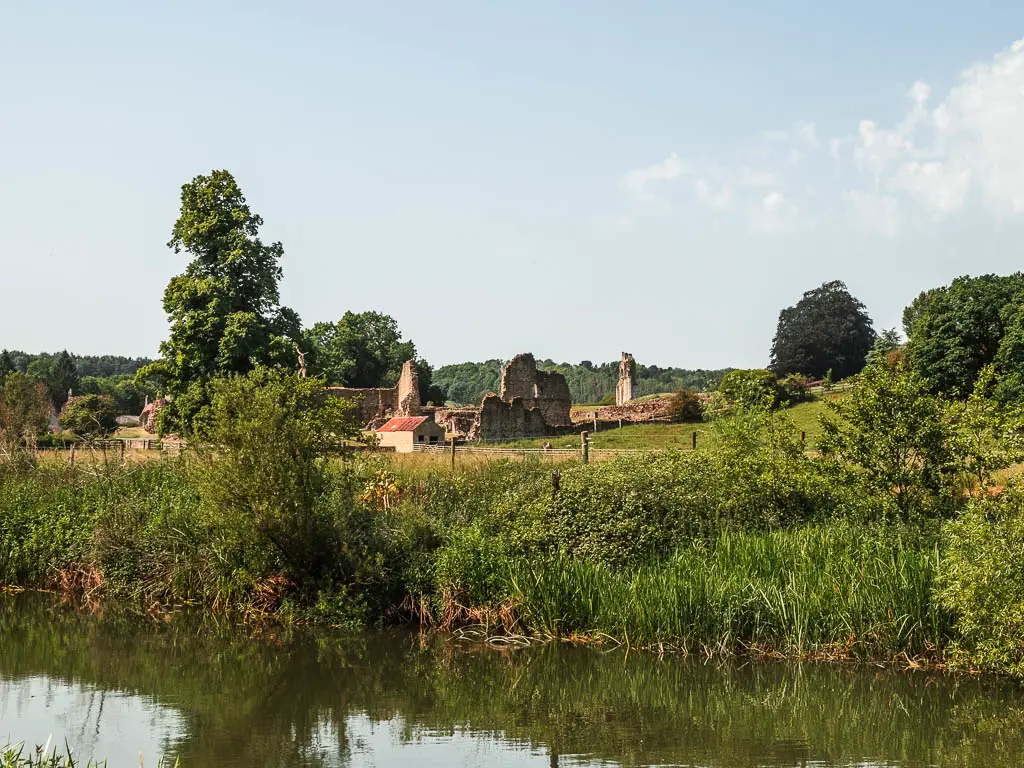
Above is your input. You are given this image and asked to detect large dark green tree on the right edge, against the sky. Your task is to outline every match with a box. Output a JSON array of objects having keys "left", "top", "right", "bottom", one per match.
[{"left": 903, "top": 272, "right": 1024, "bottom": 398}]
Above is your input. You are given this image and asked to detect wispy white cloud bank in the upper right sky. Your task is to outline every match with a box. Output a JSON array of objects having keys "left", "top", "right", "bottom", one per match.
[{"left": 624, "top": 40, "right": 1024, "bottom": 237}]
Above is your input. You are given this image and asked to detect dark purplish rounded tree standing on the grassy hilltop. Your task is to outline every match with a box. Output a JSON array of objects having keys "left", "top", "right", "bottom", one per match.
[{"left": 769, "top": 280, "right": 874, "bottom": 379}]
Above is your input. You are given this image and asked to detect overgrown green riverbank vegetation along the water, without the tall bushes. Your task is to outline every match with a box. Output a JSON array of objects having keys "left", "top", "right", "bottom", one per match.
[{"left": 0, "top": 456, "right": 955, "bottom": 658}]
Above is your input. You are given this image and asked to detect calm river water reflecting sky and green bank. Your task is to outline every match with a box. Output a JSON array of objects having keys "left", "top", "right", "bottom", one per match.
[{"left": 0, "top": 595, "right": 1024, "bottom": 768}]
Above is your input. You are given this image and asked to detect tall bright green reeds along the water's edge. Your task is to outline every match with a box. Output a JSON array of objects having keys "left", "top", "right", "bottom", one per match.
[{"left": 508, "top": 524, "right": 951, "bottom": 655}]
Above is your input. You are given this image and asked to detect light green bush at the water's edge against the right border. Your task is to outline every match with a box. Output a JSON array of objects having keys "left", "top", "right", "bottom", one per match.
[{"left": 937, "top": 485, "right": 1024, "bottom": 675}]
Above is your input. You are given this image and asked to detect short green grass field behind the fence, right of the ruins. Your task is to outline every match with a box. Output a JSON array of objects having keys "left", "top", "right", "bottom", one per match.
[{"left": 488, "top": 398, "right": 827, "bottom": 450}]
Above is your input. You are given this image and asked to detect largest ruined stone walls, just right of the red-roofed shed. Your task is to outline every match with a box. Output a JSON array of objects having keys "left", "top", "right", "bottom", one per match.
[{"left": 434, "top": 352, "right": 572, "bottom": 440}]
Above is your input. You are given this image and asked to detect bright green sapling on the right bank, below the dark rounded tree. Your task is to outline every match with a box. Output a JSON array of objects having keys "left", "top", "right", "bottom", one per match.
[{"left": 818, "top": 361, "right": 959, "bottom": 519}]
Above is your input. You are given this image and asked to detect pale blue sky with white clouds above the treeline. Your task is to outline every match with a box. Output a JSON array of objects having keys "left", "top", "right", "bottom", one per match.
[{"left": 0, "top": 0, "right": 1024, "bottom": 368}]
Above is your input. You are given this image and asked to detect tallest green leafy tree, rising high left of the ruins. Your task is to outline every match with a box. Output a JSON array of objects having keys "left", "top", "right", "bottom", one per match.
[{"left": 137, "top": 171, "right": 301, "bottom": 433}]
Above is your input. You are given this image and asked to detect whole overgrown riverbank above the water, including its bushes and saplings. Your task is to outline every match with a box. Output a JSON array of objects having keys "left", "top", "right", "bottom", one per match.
[{"left": 6, "top": 371, "right": 1024, "bottom": 672}]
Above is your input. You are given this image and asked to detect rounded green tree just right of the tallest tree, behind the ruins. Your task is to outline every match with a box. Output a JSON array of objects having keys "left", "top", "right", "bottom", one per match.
[{"left": 303, "top": 311, "right": 416, "bottom": 387}]
